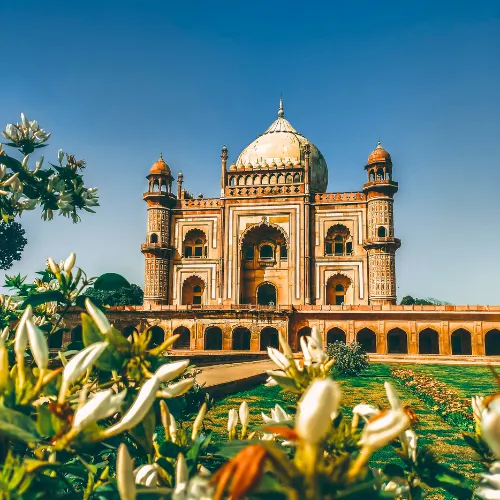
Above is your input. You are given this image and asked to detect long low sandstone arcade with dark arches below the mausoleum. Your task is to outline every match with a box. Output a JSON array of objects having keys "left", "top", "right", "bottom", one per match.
[{"left": 63, "top": 308, "right": 500, "bottom": 356}]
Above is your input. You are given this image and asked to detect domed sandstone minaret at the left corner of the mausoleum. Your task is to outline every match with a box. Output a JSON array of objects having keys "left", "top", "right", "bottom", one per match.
[{"left": 141, "top": 155, "right": 177, "bottom": 305}]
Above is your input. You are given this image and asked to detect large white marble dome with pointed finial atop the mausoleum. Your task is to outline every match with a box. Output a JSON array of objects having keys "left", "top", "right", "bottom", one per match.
[{"left": 236, "top": 100, "right": 328, "bottom": 193}]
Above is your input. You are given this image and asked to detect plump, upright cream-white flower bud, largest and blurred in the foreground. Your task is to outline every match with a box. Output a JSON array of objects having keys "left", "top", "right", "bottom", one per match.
[{"left": 295, "top": 379, "right": 340, "bottom": 444}]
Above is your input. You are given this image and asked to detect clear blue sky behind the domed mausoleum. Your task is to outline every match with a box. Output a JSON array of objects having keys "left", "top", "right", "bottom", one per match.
[{"left": 0, "top": 0, "right": 500, "bottom": 304}]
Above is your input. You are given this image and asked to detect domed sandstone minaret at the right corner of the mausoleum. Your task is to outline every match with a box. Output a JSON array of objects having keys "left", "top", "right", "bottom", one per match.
[{"left": 363, "top": 141, "right": 401, "bottom": 304}]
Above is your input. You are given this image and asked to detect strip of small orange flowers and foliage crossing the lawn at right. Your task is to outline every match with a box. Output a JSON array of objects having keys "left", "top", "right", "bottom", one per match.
[{"left": 391, "top": 369, "right": 474, "bottom": 431}]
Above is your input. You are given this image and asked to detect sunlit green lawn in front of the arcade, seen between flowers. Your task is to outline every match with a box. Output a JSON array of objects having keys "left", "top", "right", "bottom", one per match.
[{"left": 208, "top": 364, "right": 497, "bottom": 499}]
